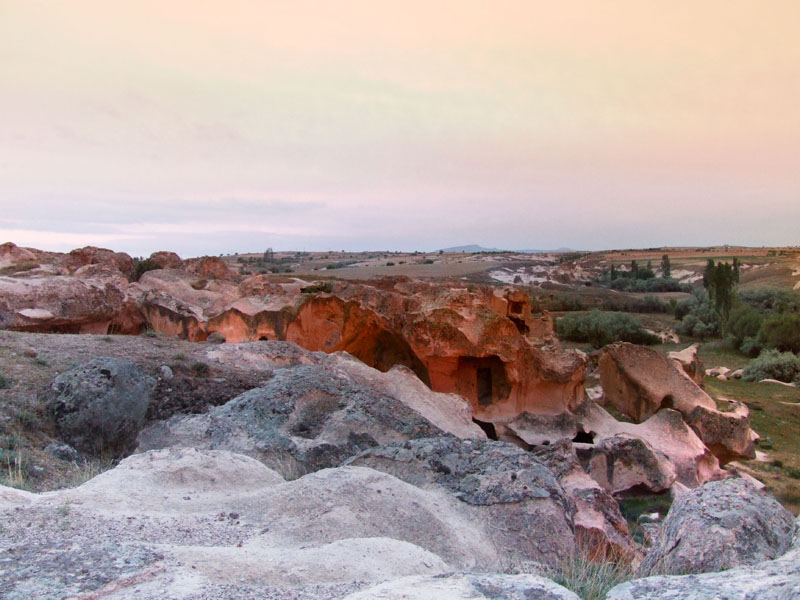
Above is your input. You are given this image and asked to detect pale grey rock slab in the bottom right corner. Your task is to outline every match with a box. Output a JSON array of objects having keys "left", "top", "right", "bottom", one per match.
[{"left": 606, "top": 520, "right": 800, "bottom": 600}]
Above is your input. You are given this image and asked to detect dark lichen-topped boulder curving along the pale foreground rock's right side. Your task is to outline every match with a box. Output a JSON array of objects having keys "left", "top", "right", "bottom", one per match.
[{"left": 346, "top": 437, "right": 575, "bottom": 568}]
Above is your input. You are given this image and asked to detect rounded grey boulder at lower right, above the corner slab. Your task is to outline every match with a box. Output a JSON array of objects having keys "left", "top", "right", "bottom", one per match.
[{"left": 639, "top": 479, "right": 794, "bottom": 575}]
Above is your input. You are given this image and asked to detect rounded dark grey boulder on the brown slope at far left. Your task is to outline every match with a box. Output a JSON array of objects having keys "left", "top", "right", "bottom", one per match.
[{"left": 49, "top": 358, "right": 155, "bottom": 456}]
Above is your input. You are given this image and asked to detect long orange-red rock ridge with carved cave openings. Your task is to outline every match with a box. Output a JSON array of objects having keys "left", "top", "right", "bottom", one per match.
[{"left": 0, "top": 247, "right": 586, "bottom": 426}]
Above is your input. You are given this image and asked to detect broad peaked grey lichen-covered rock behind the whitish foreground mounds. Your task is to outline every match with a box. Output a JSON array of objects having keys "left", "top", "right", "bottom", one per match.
[{"left": 139, "top": 362, "right": 444, "bottom": 478}]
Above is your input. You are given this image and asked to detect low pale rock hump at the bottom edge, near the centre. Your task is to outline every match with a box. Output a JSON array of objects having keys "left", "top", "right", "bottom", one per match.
[{"left": 344, "top": 573, "right": 579, "bottom": 600}]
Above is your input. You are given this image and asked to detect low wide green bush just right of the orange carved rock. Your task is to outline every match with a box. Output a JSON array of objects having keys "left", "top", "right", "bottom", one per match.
[{"left": 556, "top": 309, "right": 661, "bottom": 348}]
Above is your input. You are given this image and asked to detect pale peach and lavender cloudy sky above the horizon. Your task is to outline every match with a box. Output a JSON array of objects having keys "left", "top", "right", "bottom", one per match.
[{"left": 0, "top": 0, "right": 800, "bottom": 257}]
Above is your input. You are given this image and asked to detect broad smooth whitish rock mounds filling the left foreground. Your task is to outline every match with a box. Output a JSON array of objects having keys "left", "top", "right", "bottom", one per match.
[{"left": 0, "top": 448, "right": 575, "bottom": 600}]
